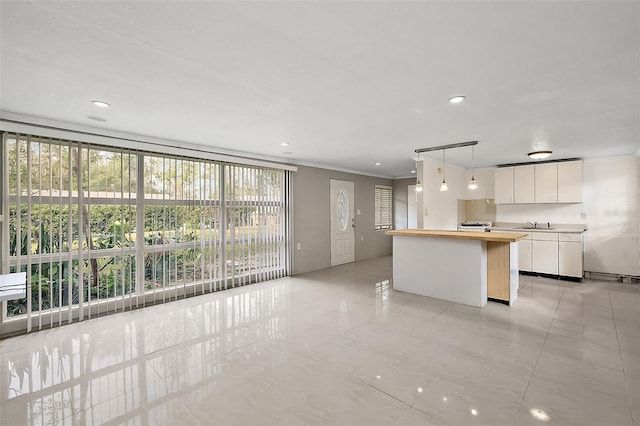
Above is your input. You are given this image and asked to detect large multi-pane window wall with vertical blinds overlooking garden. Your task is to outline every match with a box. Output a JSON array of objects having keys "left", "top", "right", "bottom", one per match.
[{"left": 2, "top": 133, "right": 288, "bottom": 331}]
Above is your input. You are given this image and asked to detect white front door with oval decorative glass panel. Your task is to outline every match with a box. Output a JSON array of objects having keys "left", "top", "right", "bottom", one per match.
[{"left": 330, "top": 179, "right": 356, "bottom": 266}]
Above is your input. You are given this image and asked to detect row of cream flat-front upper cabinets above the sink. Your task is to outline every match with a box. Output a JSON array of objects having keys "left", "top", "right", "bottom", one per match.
[{"left": 495, "top": 160, "right": 582, "bottom": 204}]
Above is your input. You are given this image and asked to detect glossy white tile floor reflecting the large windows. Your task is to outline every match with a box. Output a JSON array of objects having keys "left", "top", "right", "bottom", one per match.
[{"left": 0, "top": 257, "right": 640, "bottom": 426}]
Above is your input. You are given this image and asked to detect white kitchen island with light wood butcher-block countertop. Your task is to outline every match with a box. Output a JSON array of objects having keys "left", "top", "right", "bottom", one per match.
[{"left": 386, "top": 229, "right": 527, "bottom": 307}]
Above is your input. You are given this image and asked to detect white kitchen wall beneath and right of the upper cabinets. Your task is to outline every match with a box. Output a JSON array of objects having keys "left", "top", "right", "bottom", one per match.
[{"left": 496, "top": 156, "right": 640, "bottom": 276}]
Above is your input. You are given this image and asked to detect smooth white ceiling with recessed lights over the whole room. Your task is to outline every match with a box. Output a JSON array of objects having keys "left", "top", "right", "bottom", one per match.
[{"left": 0, "top": 1, "right": 640, "bottom": 177}]
